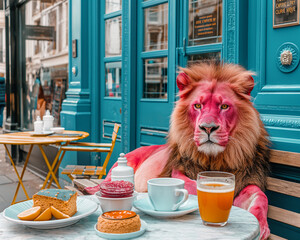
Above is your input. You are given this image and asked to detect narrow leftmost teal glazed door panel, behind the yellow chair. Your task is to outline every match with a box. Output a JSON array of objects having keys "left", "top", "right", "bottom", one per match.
[{"left": 99, "top": 0, "right": 122, "bottom": 170}]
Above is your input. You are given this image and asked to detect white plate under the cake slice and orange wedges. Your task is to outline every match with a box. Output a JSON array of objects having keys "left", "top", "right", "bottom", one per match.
[{"left": 3, "top": 197, "right": 98, "bottom": 229}]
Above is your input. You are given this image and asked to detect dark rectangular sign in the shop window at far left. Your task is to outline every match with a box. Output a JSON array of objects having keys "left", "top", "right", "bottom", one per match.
[{"left": 24, "top": 25, "right": 56, "bottom": 41}]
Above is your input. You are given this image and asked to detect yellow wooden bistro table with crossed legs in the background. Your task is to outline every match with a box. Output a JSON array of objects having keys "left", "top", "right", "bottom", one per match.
[{"left": 0, "top": 131, "right": 89, "bottom": 204}]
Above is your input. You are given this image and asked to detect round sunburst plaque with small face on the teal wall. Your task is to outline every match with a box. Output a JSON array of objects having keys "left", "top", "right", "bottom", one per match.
[{"left": 276, "top": 42, "right": 299, "bottom": 73}]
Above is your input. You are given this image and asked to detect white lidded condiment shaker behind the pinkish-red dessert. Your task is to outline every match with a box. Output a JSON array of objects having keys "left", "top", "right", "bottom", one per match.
[{"left": 111, "top": 153, "right": 134, "bottom": 184}]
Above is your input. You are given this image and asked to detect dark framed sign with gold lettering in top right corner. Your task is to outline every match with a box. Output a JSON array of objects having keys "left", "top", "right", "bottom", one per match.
[{"left": 273, "top": 0, "right": 300, "bottom": 28}]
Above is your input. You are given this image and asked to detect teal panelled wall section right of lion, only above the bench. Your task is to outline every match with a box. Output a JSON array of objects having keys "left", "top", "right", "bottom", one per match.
[{"left": 249, "top": 1, "right": 300, "bottom": 151}]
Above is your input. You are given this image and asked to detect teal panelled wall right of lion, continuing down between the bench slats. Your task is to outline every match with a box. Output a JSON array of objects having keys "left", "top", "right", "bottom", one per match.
[{"left": 248, "top": 0, "right": 300, "bottom": 239}]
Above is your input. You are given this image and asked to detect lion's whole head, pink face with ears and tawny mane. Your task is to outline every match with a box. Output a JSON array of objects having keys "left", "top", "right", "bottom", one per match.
[{"left": 168, "top": 64, "right": 262, "bottom": 161}]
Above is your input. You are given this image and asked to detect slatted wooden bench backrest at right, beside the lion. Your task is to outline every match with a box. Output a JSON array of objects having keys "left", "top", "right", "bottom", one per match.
[{"left": 267, "top": 150, "right": 300, "bottom": 240}]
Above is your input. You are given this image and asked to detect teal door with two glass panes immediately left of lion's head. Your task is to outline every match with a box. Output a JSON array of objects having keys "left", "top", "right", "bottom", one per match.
[{"left": 136, "top": 0, "right": 176, "bottom": 147}]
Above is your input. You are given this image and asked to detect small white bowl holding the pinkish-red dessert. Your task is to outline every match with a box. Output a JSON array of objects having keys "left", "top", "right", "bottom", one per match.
[{"left": 95, "top": 192, "right": 137, "bottom": 212}]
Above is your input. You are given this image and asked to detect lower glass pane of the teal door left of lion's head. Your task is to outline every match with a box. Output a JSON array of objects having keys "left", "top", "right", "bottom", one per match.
[{"left": 143, "top": 57, "right": 168, "bottom": 99}]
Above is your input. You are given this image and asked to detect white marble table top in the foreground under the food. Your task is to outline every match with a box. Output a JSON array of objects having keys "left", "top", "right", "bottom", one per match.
[{"left": 0, "top": 195, "right": 259, "bottom": 240}]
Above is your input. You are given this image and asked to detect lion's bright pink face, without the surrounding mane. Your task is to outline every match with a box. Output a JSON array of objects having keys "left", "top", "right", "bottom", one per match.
[{"left": 188, "top": 81, "right": 238, "bottom": 155}]
